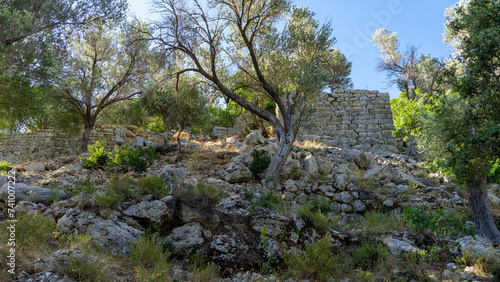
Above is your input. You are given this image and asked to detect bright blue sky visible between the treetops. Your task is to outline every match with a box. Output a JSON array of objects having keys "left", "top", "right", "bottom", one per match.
[{"left": 129, "top": 0, "right": 458, "bottom": 98}]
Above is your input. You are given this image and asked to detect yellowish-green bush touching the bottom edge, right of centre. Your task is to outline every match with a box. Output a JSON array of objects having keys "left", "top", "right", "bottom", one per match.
[{"left": 283, "top": 235, "right": 339, "bottom": 281}]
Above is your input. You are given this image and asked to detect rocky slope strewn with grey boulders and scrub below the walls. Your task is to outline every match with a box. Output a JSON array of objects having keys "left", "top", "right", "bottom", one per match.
[{"left": 0, "top": 132, "right": 500, "bottom": 281}]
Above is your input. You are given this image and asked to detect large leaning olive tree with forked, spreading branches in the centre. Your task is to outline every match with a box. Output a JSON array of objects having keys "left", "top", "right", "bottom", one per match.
[{"left": 149, "top": 0, "right": 334, "bottom": 185}]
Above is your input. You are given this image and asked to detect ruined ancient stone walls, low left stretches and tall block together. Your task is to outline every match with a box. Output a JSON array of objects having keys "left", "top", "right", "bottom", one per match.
[{"left": 0, "top": 89, "right": 398, "bottom": 164}]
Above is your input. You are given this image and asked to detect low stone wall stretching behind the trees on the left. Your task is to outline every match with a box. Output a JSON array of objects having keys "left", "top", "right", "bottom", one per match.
[{"left": 0, "top": 124, "right": 163, "bottom": 164}]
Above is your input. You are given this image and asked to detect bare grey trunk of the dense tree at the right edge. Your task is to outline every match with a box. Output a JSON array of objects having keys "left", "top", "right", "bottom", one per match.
[{"left": 468, "top": 174, "right": 500, "bottom": 246}]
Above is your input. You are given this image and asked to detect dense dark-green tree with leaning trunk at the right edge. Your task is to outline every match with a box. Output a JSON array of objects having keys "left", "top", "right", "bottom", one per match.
[{"left": 420, "top": 0, "right": 500, "bottom": 246}]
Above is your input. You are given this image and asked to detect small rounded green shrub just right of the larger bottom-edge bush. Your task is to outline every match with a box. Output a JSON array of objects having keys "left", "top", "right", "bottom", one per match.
[{"left": 352, "top": 242, "right": 389, "bottom": 270}]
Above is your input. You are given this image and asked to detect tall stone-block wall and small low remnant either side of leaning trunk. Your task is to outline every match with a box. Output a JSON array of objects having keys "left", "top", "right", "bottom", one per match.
[{"left": 213, "top": 89, "right": 398, "bottom": 152}]
